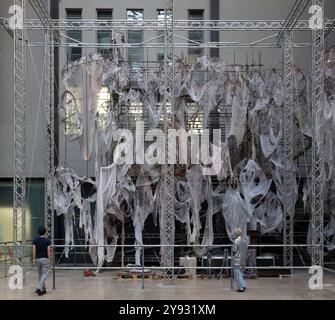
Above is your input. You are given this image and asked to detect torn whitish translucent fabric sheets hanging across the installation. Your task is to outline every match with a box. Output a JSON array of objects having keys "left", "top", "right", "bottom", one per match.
[{"left": 55, "top": 49, "right": 335, "bottom": 266}]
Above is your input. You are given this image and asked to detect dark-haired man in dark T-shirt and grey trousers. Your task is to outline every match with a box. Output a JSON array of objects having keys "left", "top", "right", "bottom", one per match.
[{"left": 33, "top": 227, "right": 51, "bottom": 296}]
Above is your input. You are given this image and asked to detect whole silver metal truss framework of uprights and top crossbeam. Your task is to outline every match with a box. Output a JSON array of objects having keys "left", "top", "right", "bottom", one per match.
[{"left": 1, "top": 0, "right": 334, "bottom": 275}]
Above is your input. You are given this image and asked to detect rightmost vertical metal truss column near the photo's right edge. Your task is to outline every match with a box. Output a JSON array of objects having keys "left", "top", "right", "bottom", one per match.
[{"left": 311, "top": 0, "right": 324, "bottom": 267}]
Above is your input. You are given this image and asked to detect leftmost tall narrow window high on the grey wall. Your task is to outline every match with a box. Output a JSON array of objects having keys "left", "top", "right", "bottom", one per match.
[{"left": 66, "top": 9, "right": 82, "bottom": 62}]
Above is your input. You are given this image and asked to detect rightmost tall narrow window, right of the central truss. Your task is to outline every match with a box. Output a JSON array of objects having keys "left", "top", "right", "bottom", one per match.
[{"left": 188, "top": 9, "right": 204, "bottom": 64}]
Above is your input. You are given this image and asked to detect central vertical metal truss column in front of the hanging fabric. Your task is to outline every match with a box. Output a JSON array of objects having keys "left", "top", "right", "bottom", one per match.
[{"left": 161, "top": 0, "right": 175, "bottom": 277}]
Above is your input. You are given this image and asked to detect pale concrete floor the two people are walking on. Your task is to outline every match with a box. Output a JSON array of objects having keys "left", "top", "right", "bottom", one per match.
[{"left": 0, "top": 270, "right": 335, "bottom": 300}]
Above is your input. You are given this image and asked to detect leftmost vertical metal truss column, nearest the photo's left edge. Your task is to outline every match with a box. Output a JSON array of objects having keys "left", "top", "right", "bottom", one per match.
[{"left": 13, "top": 0, "right": 26, "bottom": 268}]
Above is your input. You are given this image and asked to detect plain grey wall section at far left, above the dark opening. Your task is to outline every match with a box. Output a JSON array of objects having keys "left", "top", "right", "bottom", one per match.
[{"left": 0, "top": 0, "right": 44, "bottom": 177}]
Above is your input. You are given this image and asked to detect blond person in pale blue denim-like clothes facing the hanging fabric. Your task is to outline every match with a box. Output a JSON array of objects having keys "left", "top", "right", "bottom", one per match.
[{"left": 232, "top": 228, "right": 248, "bottom": 292}]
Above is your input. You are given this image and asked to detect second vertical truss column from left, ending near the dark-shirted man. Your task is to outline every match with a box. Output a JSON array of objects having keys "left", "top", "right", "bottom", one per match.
[{"left": 44, "top": 29, "right": 55, "bottom": 244}]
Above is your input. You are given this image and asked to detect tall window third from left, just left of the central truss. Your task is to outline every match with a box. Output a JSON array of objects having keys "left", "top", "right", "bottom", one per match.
[{"left": 127, "top": 9, "right": 144, "bottom": 74}]
